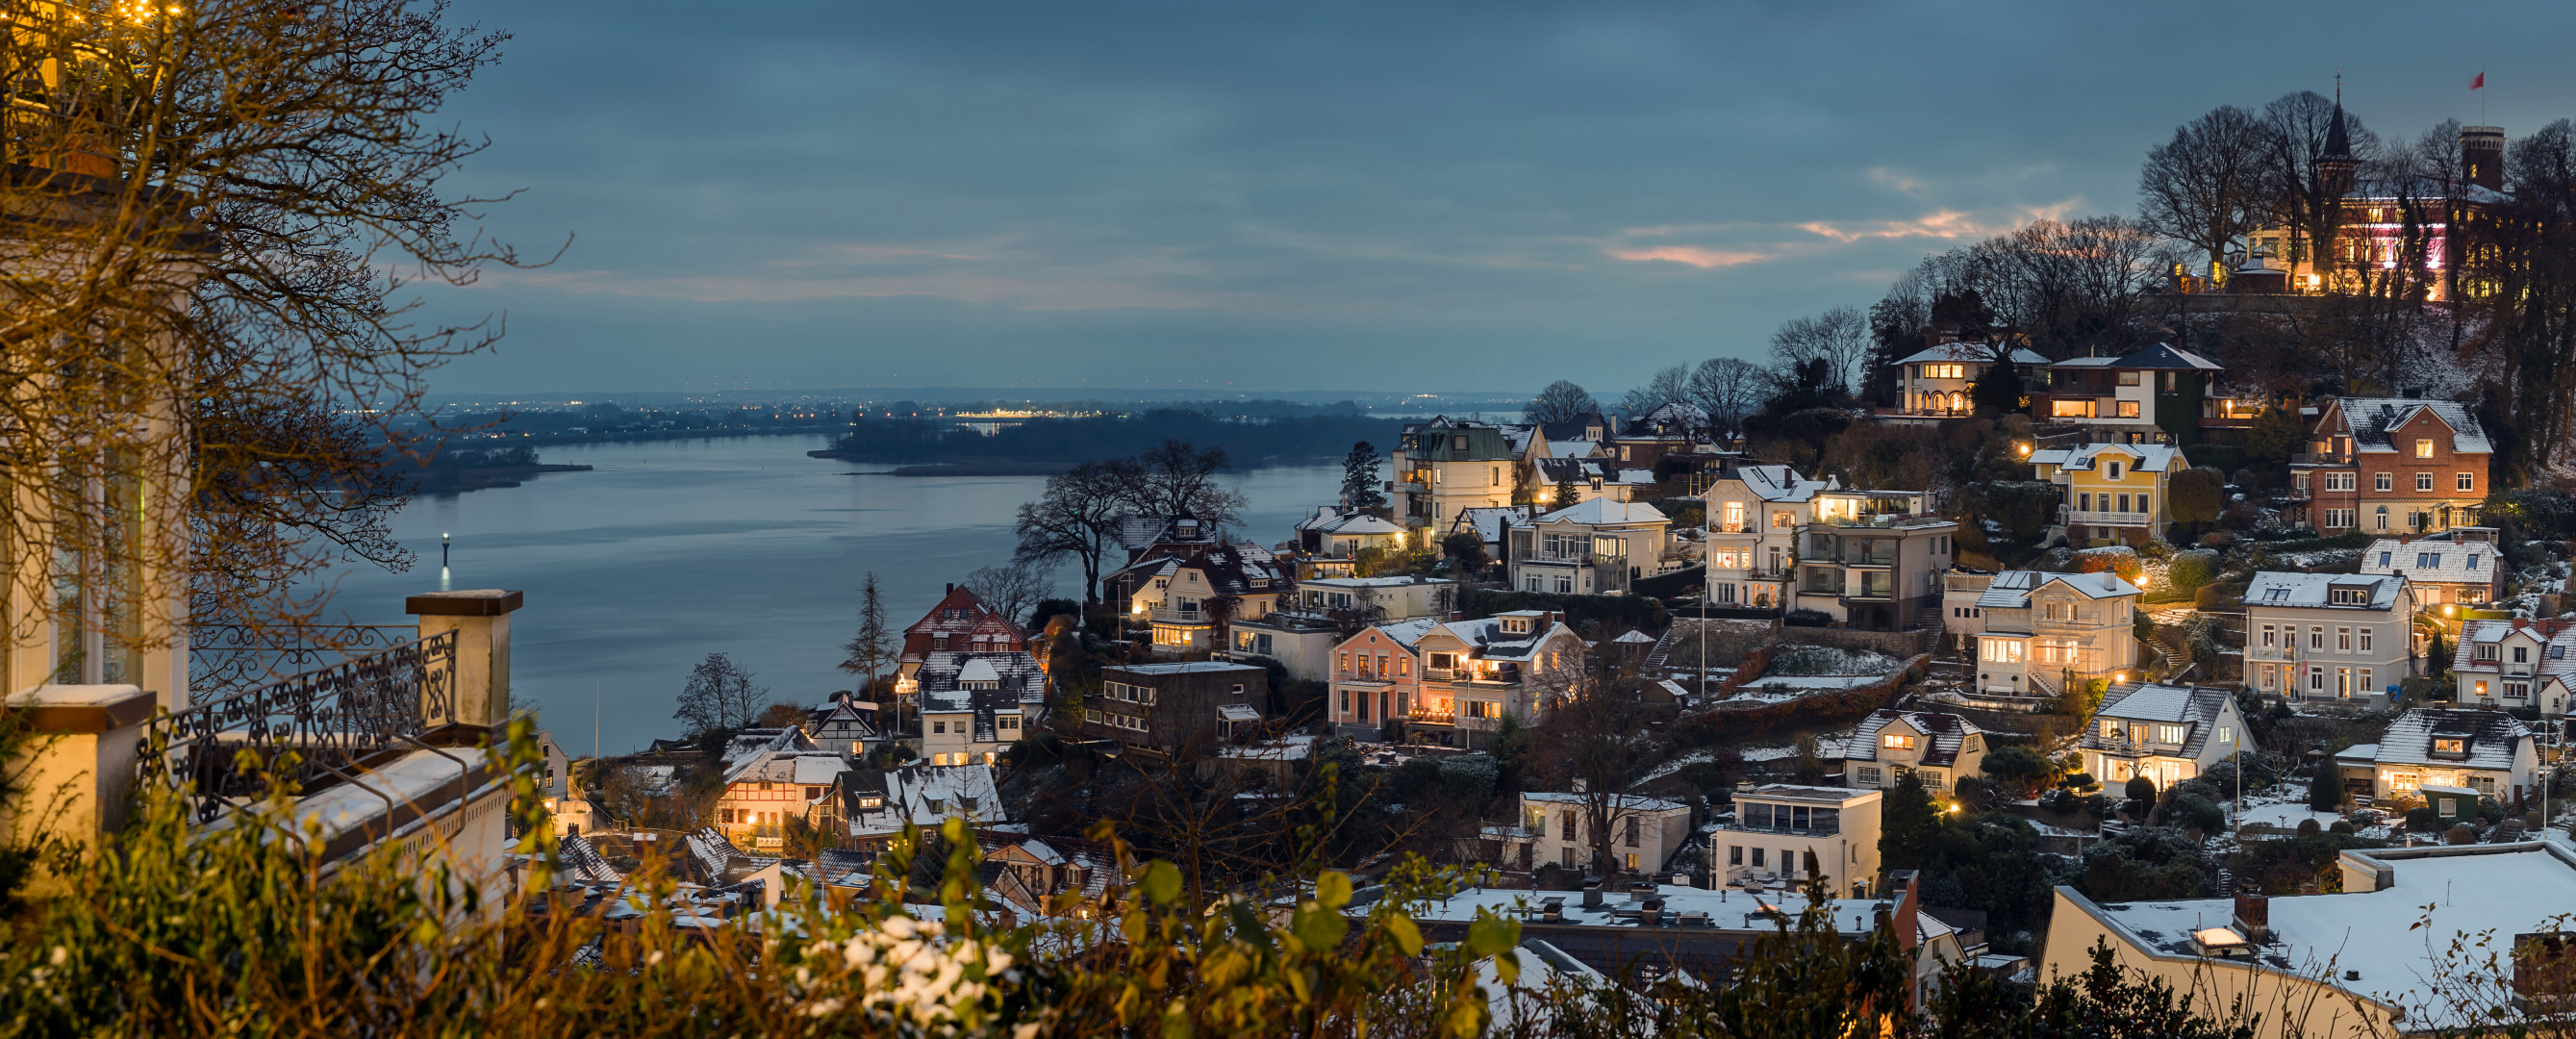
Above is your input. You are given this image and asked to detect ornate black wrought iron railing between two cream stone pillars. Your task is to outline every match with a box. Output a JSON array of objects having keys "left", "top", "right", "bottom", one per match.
[{"left": 134, "top": 632, "right": 456, "bottom": 823}]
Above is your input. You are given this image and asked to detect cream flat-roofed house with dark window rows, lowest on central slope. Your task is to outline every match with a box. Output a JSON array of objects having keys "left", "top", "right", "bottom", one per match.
[{"left": 1708, "top": 784, "right": 1885, "bottom": 898}]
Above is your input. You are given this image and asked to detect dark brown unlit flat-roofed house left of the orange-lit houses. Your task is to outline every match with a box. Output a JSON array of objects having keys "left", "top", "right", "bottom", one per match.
[{"left": 1082, "top": 660, "right": 1270, "bottom": 758}]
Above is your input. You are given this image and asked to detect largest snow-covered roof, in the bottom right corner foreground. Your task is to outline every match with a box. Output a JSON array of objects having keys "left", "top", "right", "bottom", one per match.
[{"left": 2079, "top": 841, "right": 2576, "bottom": 1031}]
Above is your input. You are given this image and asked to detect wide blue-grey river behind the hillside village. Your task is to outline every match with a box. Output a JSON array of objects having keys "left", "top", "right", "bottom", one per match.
[{"left": 306, "top": 436, "right": 1342, "bottom": 753}]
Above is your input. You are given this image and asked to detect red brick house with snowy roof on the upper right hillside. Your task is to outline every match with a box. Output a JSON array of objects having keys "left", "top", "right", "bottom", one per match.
[{"left": 2290, "top": 397, "right": 2496, "bottom": 534}]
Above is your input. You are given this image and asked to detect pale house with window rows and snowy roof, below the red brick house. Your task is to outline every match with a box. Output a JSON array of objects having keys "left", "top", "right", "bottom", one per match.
[{"left": 2246, "top": 570, "right": 2416, "bottom": 704}]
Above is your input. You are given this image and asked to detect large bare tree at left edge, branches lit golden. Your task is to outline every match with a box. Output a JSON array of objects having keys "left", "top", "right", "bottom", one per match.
[{"left": 0, "top": 0, "right": 538, "bottom": 652}]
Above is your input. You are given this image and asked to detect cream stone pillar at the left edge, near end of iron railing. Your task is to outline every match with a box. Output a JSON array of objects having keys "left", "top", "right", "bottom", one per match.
[{"left": 0, "top": 686, "right": 160, "bottom": 871}]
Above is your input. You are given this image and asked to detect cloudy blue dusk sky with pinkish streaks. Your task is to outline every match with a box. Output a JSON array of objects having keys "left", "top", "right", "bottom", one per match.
[{"left": 412, "top": 0, "right": 2576, "bottom": 394}]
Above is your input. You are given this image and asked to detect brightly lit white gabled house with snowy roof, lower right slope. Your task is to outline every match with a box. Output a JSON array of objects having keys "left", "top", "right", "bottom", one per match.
[{"left": 2076, "top": 683, "right": 2252, "bottom": 789}]
